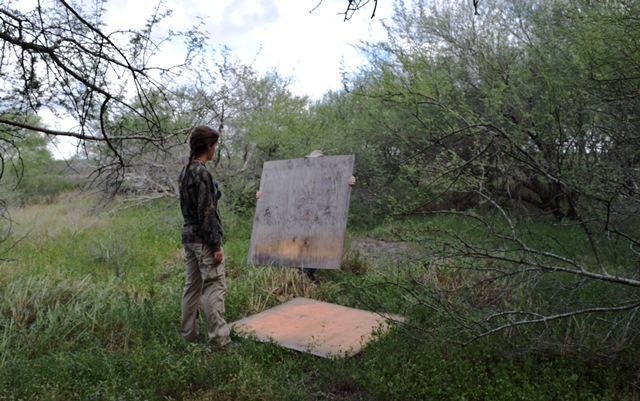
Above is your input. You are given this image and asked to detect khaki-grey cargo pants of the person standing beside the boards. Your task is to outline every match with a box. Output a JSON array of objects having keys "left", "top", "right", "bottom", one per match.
[{"left": 180, "top": 243, "right": 230, "bottom": 346}]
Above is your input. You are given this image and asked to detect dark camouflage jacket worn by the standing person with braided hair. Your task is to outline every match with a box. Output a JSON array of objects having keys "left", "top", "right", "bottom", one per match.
[{"left": 178, "top": 161, "right": 222, "bottom": 251}]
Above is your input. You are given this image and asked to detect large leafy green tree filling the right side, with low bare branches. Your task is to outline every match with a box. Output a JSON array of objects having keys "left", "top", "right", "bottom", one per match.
[{"left": 342, "top": 0, "right": 640, "bottom": 352}]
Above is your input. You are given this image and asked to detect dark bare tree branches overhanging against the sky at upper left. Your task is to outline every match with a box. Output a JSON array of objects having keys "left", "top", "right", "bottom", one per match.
[{"left": 0, "top": 0, "right": 204, "bottom": 186}]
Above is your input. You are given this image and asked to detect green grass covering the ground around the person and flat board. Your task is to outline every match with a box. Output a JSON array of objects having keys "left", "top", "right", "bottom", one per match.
[{"left": 0, "top": 196, "right": 640, "bottom": 401}]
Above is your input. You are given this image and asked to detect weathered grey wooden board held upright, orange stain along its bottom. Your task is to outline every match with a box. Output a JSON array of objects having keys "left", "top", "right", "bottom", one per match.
[{"left": 249, "top": 155, "right": 355, "bottom": 269}]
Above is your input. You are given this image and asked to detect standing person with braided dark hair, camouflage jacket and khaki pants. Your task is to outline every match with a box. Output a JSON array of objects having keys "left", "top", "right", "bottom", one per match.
[{"left": 178, "top": 125, "right": 237, "bottom": 348}]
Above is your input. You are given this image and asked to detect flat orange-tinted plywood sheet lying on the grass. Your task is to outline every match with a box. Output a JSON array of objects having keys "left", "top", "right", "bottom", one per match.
[{"left": 231, "top": 298, "right": 400, "bottom": 358}]
